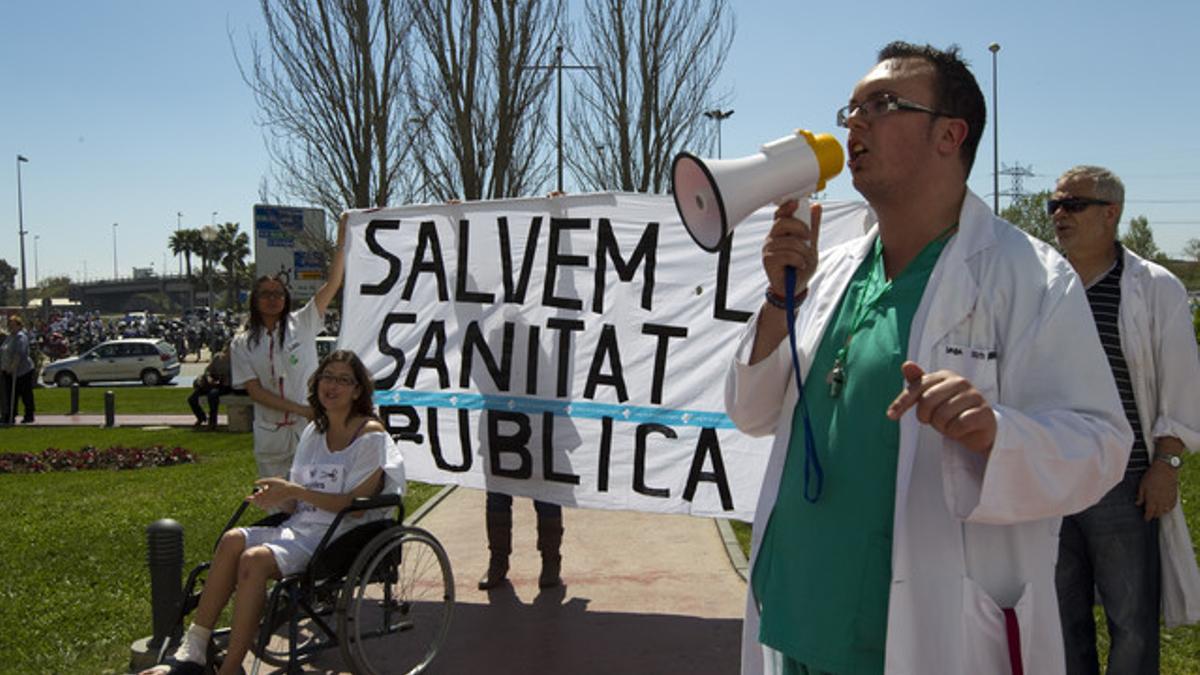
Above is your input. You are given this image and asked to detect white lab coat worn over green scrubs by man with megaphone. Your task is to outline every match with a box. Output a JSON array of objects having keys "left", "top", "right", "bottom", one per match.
[{"left": 726, "top": 192, "right": 1133, "bottom": 675}]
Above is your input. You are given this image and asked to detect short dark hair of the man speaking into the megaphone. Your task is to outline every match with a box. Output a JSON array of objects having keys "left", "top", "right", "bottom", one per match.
[{"left": 878, "top": 40, "right": 988, "bottom": 175}]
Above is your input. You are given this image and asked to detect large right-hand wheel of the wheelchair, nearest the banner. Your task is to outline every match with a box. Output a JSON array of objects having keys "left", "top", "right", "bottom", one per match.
[{"left": 336, "top": 527, "right": 454, "bottom": 674}]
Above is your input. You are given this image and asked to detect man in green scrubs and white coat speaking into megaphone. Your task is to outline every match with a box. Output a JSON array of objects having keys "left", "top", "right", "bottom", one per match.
[{"left": 727, "top": 42, "right": 1132, "bottom": 675}]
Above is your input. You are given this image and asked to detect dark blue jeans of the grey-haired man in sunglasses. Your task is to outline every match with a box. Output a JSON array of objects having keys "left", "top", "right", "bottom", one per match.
[{"left": 1056, "top": 473, "right": 1162, "bottom": 675}]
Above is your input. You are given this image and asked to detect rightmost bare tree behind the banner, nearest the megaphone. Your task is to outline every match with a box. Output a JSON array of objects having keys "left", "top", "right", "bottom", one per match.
[{"left": 566, "top": 0, "right": 734, "bottom": 192}]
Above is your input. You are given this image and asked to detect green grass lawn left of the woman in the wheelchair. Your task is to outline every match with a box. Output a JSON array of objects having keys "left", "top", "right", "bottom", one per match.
[{"left": 0, "top": 427, "right": 437, "bottom": 674}]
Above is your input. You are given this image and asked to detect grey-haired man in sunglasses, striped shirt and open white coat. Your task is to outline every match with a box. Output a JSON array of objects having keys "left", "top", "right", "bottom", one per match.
[{"left": 1046, "top": 166, "right": 1200, "bottom": 675}]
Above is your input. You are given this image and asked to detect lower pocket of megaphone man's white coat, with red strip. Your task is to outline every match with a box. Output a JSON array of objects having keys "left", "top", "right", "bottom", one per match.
[{"left": 962, "top": 577, "right": 1033, "bottom": 675}]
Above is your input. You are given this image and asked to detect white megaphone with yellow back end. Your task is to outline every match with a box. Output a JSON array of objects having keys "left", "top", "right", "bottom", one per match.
[{"left": 671, "top": 129, "right": 846, "bottom": 253}]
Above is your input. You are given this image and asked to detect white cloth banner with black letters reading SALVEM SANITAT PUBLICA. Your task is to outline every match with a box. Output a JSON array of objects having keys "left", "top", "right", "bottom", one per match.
[{"left": 338, "top": 193, "right": 869, "bottom": 520}]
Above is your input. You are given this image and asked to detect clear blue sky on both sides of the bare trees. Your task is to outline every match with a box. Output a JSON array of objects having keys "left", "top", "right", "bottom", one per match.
[{"left": 0, "top": 0, "right": 1200, "bottom": 286}]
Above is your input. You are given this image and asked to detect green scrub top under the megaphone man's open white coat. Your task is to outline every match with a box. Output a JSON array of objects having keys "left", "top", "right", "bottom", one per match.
[{"left": 751, "top": 228, "right": 953, "bottom": 675}]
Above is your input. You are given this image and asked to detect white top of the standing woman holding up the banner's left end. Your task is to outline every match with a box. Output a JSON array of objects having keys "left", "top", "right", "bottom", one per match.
[{"left": 229, "top": 300, "right": 324, "bottom": 426}]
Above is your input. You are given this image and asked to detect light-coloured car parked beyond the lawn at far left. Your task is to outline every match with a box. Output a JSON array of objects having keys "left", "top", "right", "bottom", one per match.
[{"left": 42, "top": 338, "right": 179, "bottom": 387}]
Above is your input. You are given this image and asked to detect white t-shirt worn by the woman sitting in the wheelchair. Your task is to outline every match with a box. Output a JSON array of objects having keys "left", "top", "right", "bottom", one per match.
[{"left": 286, "top": 423, "right": 404, "bottom": 536}]
